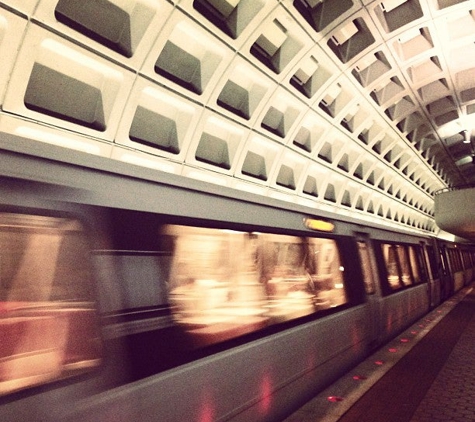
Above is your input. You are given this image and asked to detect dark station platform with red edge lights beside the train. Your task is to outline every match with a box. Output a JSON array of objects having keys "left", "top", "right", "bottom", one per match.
[{"left": 285, "top": 284, "right": 475, "bottom": 422}]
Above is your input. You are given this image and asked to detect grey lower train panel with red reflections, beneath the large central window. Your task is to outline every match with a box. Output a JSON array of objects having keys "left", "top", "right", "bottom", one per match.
[{"left": 62, "top": 305, "right": 370, "bottom": 422}]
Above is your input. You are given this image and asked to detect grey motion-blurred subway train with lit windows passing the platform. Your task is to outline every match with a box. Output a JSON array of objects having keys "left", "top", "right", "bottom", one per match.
[{"left": 0, "top": 146, "right": 475, "bottom": 422}]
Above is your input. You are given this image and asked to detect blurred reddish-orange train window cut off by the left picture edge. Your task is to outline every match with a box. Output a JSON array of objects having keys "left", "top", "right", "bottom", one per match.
[{"left": 0, "top": 213, "right": 101, "bottom": 395}]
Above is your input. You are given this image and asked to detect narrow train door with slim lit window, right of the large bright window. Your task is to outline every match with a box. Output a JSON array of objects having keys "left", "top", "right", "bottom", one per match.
[{"left": 356, "top": 233, "right": 381, "bottom": 347}]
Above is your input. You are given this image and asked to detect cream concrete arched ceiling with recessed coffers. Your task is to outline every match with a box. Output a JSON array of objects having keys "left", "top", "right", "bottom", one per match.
[{"left": 0, "top": 0, "right": 475, "bottom": 237}]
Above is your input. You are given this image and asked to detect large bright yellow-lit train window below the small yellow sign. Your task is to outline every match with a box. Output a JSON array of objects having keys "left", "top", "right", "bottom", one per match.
[{"left": 163, "top": 225, "right": 347, "bottom": 346}]
